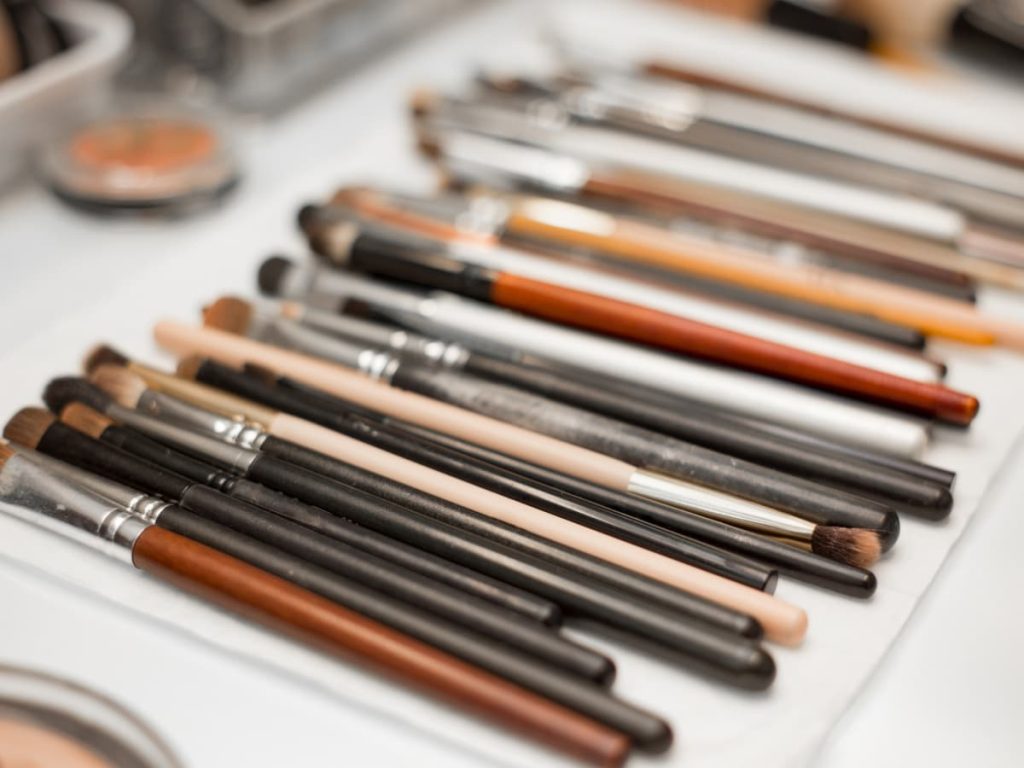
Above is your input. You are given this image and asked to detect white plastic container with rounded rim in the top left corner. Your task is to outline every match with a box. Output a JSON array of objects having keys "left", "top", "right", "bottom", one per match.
[{"left": 0, "top": 0, "right": 132, "bottom": 193}]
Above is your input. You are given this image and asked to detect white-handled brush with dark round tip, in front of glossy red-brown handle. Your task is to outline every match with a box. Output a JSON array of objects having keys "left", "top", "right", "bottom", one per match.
[{"left": 259, "top": 257, "right": 928, "bottom": 456}]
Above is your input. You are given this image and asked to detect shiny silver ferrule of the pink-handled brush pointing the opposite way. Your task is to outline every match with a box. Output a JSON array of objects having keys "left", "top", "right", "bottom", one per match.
[{"left": 629, "top": 470, "right": 815, "bottom": 541}]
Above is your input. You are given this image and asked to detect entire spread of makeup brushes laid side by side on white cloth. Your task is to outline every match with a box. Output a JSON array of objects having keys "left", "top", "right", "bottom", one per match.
[{"left": 9, "top": 51, "right": 1024, "bottom": 765}]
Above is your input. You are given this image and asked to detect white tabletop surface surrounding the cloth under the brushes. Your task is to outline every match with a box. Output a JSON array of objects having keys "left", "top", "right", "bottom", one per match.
[{"left": 0, "top": 3, "right": 1024, "bottom": 768}]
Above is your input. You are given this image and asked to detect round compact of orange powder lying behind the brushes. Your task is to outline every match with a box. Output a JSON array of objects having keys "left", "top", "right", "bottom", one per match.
[{"left": 44, "top": 110, "right": 239, "bottom": 215}]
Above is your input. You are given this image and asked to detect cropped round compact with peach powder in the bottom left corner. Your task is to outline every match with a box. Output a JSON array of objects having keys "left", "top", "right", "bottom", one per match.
[{"left": 0, "top": 666, "right": 181, "bottom": 768}]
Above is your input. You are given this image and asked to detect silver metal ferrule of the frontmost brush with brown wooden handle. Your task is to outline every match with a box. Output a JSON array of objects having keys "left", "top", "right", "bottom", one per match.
[{"left": 0, "top": 455, "right": 152, "bottom": 563}]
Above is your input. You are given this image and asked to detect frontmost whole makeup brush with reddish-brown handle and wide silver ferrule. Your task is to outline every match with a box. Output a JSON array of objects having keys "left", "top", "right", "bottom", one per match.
[{"left": 0, "top": 445, "right": 630, "bottom": 766}]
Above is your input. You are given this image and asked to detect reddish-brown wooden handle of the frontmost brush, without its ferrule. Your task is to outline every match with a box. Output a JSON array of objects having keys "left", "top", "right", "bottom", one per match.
[{"left": 132, "top": 525, "right": 631, "bottom": 766}]
